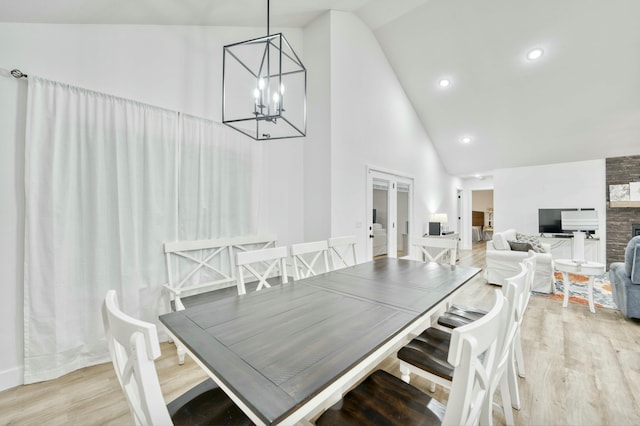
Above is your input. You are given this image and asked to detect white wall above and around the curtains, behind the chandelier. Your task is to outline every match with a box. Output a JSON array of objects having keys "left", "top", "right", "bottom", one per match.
[{"left": 0, "top": 24, "right": 304, "bottom": 390}]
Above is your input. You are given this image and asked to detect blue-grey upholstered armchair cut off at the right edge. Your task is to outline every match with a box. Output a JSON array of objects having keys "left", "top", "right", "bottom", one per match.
[{"left": 609, "top": 236, "right": 640, "bottom": 319}]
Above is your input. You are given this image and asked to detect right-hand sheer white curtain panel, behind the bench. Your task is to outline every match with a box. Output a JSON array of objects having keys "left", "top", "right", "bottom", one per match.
[{"left": 178, "top": 115, "right": 262, "bottom": 240}]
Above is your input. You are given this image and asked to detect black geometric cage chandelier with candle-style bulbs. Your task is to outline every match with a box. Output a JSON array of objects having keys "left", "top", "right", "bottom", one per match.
[{"left": 222, "top": 0, "right": 307, "bottom": 140}]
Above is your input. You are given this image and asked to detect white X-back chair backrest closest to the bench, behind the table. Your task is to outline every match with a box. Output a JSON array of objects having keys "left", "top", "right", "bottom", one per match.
[{"left": 236, "top": 246, "right": 288, "bottom": 295}]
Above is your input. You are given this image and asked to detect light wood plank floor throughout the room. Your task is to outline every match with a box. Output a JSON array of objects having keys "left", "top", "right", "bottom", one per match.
[{"left": 0, "top": 243, "right": 640, "bottom": 425}]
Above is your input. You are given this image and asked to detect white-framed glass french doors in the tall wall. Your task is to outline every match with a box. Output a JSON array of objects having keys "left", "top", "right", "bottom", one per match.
[{"left": 367, "top": 168, "right": 413, "bottom": 259}]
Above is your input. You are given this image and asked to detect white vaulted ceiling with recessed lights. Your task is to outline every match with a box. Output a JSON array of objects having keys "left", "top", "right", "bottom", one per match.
[{"left": 5, "top": 0, "right": 640, "bottom": 177}]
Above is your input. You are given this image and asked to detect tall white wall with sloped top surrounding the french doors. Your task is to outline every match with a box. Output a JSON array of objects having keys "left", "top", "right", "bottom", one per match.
[{"left": 328, "top": 11, "right": 457, "bottom": 259}]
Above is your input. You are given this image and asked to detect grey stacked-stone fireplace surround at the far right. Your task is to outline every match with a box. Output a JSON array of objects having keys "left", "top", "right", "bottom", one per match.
[{"left": 605, "top": 155, "right": 640, "bottom": 269}]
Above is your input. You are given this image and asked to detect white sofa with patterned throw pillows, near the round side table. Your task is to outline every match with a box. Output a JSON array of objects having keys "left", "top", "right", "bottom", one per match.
[{"left": 485, "top": 229, "right": 553, "bottom": 293}]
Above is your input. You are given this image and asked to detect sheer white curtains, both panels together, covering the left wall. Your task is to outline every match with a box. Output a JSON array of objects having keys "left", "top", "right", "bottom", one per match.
[{"left": 24, "top": 76, "right": 260, "bottom": 383}]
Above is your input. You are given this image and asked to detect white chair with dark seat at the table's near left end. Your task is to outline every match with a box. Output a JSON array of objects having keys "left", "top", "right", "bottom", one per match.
[{"left": 102, "top": 290, "right": 252, "bottom": 425}]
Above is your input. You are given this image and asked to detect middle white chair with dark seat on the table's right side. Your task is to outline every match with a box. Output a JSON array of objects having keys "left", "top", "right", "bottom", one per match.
[{"left": 397, "top": 266, "right": 527, "bottom": 425}]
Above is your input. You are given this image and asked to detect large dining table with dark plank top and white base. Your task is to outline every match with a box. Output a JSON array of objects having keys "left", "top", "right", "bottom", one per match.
[{"left": 160, "top": 257, "right": 480, "bottom": 425}]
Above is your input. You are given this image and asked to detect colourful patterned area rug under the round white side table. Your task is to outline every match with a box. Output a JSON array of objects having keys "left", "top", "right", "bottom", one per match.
[{"left": 538, "top": 272, "right": 618, "bottom": 309}]
